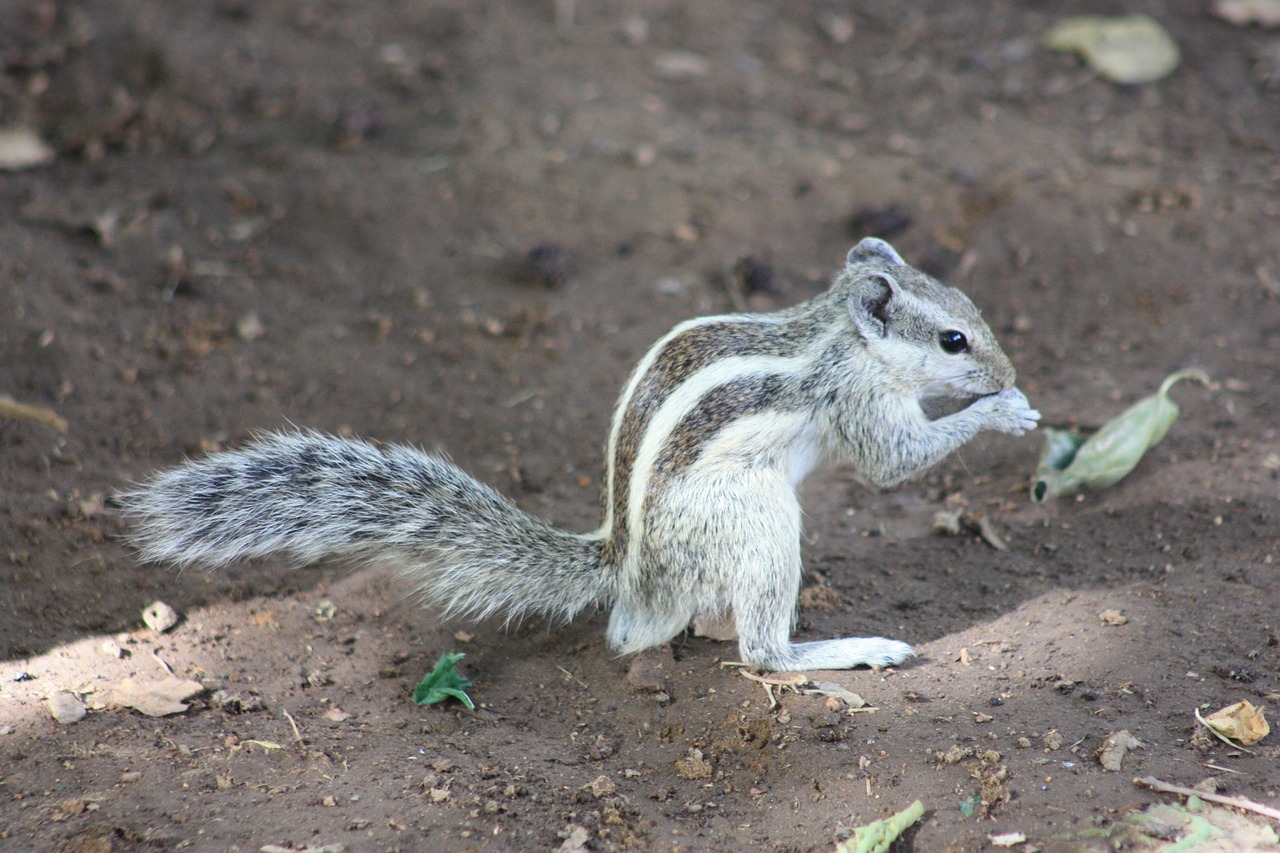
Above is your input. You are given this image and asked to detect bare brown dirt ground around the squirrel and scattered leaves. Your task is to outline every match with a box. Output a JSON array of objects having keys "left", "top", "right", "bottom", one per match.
[{"left": 0, "top": 0, "right": 1280, "bottom": 852}]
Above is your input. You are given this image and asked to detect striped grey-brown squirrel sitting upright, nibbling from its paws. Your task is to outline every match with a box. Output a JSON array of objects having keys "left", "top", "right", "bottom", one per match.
[{"left": 119, "top": 238, "right": 1039, "bottom": 671}]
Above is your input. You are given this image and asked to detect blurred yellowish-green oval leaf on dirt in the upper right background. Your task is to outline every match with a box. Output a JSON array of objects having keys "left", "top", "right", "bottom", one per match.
[{"left": 1041, "top": 14, "right": 1181, "bottom": 85}]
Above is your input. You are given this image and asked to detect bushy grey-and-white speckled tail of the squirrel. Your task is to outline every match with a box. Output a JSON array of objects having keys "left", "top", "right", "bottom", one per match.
[{"left": 119, "top": 432, "right": 612, "bottom": 619}]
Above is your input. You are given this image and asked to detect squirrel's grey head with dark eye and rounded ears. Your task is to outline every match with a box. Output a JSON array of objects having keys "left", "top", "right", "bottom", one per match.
[{"left": 835, "top": 237, "right": 1018, "bottom": 398}]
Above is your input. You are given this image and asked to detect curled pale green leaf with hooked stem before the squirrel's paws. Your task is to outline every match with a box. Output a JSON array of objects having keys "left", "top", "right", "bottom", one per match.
[{"left": 1032, "top": 370, "right": 1210, "bottom": 503}]
